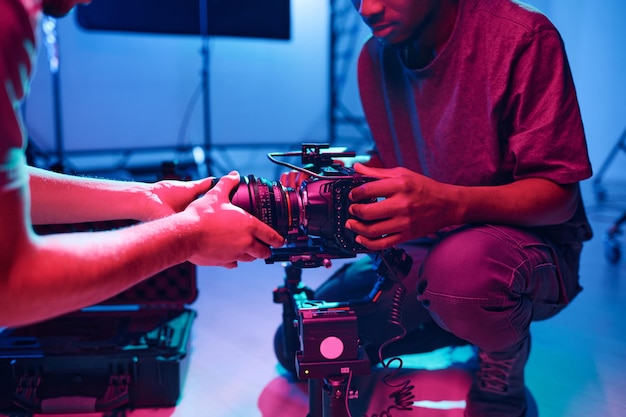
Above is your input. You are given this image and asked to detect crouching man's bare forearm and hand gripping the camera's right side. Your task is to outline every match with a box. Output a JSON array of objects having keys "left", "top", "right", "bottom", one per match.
[{"left": 346, "top": 165, "right": 578, "bottom": 250}]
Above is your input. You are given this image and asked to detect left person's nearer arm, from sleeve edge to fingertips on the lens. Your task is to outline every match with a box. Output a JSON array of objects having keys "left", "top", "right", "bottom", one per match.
[{"left": 0, "top": 174, "right": 283, "bottom": 326}]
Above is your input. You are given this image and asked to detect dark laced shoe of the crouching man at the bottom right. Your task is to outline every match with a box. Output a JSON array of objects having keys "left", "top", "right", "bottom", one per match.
[{"left": 465, "top": 335, "right": 530, "bottom": 417}]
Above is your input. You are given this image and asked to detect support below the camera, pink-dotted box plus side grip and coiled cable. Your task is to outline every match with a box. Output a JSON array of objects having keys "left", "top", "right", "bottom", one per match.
[{"left": 274, "top": 248, "right": 413, "bottom": 417}]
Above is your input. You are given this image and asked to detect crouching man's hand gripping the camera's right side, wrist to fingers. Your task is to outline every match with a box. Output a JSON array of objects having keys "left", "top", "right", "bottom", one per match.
[{"left": 346, "top": 164, "right": 456, "bottom": 250}]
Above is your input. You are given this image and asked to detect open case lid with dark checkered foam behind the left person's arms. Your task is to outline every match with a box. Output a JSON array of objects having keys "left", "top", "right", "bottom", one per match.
[{"left": 33, "top": 220, "right": 198, "bottom": 308}]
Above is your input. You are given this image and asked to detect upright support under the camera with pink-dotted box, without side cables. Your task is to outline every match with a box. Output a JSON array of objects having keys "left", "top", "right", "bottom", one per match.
[{"left": 274, "top": 263, "right": 370, "bottom": 417}]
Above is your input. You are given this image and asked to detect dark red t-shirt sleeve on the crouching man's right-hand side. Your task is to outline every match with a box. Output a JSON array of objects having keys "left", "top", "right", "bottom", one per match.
[{"left": 506, "top": 28, "right": 592, "bottom": 184}]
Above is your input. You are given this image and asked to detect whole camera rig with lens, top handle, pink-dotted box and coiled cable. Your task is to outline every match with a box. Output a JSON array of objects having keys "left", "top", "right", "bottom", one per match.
[{"left": 225, "top": 143, "right": 413, "bottom": 417}]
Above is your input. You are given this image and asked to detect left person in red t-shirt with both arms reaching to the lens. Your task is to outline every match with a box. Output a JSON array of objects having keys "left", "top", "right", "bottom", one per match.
[{"left": 0, "top": 1, "right": 283, "bottom": 326}]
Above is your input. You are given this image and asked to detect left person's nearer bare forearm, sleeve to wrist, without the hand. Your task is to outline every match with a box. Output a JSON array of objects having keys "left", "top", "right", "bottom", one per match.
[{"left": 0, "top": 214, "right": 196, "bottom": 326}]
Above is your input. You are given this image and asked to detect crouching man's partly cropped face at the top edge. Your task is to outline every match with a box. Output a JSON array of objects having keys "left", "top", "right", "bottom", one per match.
[{"left": 352, "top": 0, "right": 439, "bottom": 45}]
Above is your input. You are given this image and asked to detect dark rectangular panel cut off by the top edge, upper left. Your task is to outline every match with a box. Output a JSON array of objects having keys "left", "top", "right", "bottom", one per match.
[{"left": 76, "top": 0, "right": 291, "bottom": 40}]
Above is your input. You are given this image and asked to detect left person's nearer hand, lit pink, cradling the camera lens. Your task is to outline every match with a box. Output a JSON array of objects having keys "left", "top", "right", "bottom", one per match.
[{"left": 185, "top": 172, "right": 285, "bottom": 268}]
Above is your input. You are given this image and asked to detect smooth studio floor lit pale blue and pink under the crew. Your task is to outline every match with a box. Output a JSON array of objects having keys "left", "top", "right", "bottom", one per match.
[{"left": 1, "top": 177, "right": 626, "bottom": 417}]
